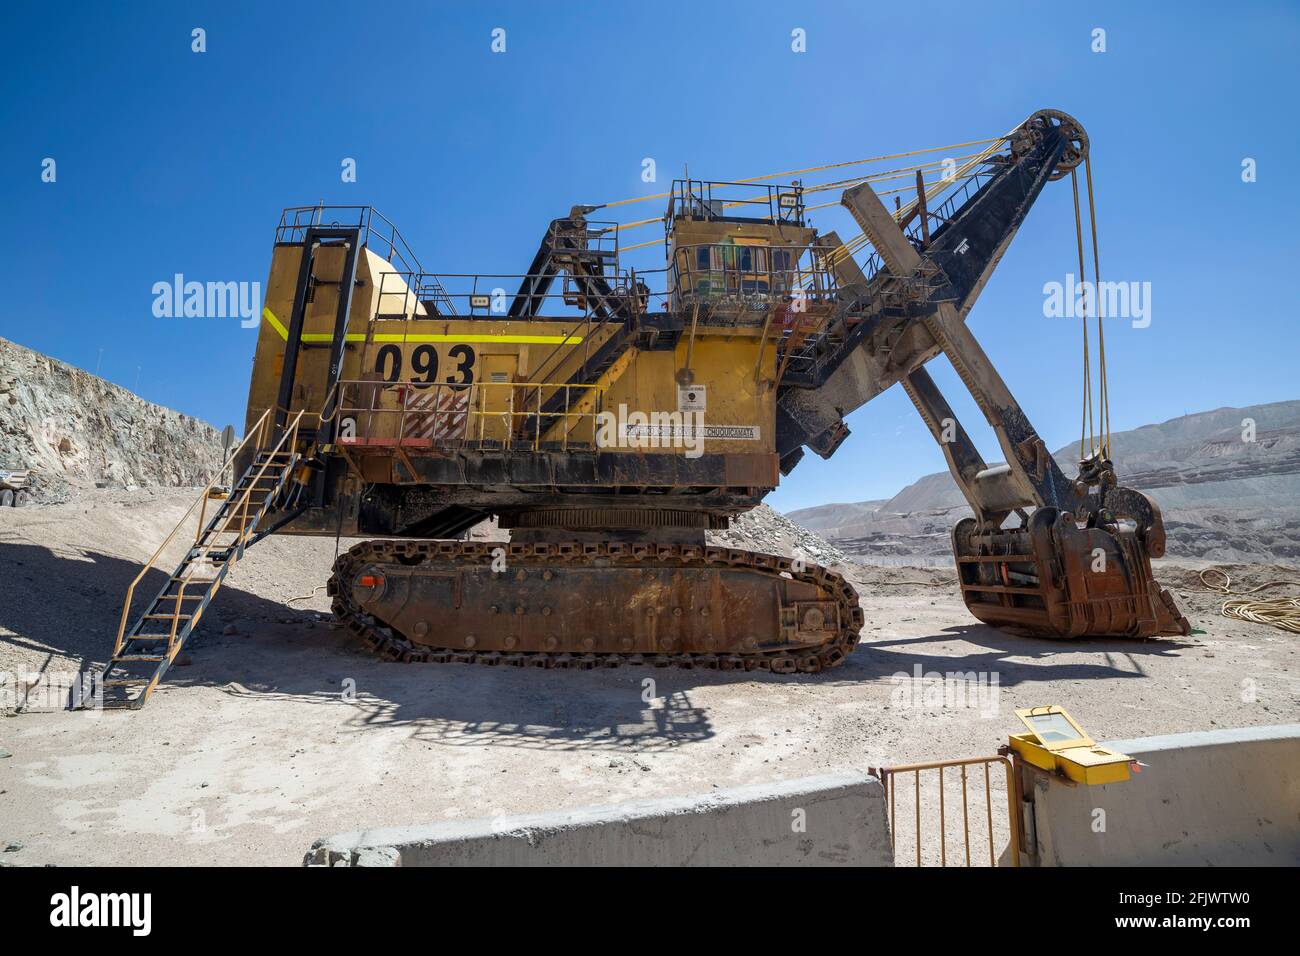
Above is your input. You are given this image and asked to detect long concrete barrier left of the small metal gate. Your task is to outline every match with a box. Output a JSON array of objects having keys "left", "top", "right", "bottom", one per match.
[{"left": 303, "top": 773, "right": 893, "bottom": 866}]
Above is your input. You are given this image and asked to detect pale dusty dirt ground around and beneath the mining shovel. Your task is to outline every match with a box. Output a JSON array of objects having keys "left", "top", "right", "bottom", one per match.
[{"left": 0, "top": 490, "right": 1300, "bottom": 865}]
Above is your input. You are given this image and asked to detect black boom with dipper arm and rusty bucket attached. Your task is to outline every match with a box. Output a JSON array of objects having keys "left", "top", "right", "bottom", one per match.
[{"left": 777, "top": 111, "right": 1190, "bottom": 636}]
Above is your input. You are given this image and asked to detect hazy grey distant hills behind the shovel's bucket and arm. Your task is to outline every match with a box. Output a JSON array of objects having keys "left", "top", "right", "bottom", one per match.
[{"left": 788, "top": 401, "right": 1300, "bottom": 559}]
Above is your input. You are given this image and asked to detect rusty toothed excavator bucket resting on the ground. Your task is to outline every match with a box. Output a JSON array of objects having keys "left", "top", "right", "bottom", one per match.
[{"left": 953, "top": 488, "right": 1191, "bottom": 637}]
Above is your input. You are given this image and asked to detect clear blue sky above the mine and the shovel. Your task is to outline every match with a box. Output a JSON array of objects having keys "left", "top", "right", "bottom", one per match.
[{"left": 0, "top": 0, "right": 1300, "bottom": 510}]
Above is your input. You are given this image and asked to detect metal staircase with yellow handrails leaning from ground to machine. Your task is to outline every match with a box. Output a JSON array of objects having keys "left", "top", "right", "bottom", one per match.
[{"left": 96, "top": 410, "right": 303, "bottom": 710}]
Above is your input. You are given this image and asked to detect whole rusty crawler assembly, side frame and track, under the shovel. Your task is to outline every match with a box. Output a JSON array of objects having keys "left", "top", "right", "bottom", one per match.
[{"left": 329, "top": 541, "right": 863, "bottom": 674}]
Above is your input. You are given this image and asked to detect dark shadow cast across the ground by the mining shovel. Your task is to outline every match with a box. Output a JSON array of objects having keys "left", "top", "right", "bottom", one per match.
[{"left": 0, "top": 544, "right": 1187, "bottom": 752}]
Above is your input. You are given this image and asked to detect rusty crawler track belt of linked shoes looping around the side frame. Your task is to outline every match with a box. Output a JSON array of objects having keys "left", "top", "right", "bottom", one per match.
[{"left": 328, "top": 540, "right": 863, "bottom": 674}]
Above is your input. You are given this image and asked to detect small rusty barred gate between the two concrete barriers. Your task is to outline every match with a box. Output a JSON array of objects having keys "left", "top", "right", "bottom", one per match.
[{"left": 875, "top": 756, "right": 1021, "bottom": 866}]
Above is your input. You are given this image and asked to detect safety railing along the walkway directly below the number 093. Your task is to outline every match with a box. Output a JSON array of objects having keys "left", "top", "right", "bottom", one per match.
[{"left": 327, "top": 380, "right": 607, "bottom": 453}]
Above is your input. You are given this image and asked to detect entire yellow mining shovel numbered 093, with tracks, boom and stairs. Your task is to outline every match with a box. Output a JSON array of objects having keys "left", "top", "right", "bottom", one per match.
[{"left": 96, "top": 111, "right": 1188, "bottom": 706}]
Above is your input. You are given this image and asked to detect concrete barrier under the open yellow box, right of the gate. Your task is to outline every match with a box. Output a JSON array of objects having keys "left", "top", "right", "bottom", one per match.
[{"left": 1022, "top": 723, "right": 1300, "bottom": 866}]
